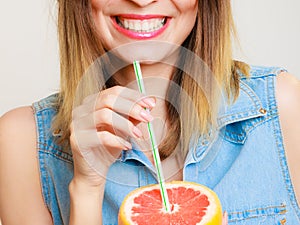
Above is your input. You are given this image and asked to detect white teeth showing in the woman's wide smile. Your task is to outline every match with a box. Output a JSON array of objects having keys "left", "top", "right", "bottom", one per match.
[{"left": 117, "top": 18, "right": 165, "bottom": 32}]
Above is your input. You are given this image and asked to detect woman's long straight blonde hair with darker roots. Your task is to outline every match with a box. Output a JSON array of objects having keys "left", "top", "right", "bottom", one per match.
[{"left": 53, "top": 0, "right": 248, "bottom": 158}]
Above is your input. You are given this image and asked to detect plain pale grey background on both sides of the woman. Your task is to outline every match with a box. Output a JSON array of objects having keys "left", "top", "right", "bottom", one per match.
[{"left": 0, "top": 0, "right": 300, "bottom": 115}]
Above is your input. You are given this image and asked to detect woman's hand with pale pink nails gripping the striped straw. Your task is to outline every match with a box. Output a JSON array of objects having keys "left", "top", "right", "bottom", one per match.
[{"left": 70, "top": 86, "right": 155, "bottom": 186}]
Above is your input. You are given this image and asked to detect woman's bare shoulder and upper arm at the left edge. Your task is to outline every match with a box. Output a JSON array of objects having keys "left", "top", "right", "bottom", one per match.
[{"left": 0, "top": 106, "right": 51, "bottom": 224}]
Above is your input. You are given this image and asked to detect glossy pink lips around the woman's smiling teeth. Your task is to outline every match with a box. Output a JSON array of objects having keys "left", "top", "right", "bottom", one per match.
[{"left": 112, "top": 14, "right": 170, "bottom": 40}]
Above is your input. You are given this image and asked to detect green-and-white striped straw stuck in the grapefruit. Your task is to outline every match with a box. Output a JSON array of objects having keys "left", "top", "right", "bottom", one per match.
[{"left": 133, "top": 61, "right": 171, "bottom": 212}]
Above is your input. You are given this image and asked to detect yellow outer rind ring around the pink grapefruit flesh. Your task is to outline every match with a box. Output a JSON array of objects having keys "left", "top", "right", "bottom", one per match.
[{"left": 118, "top": 181, "right": 222, "bottom": 225}]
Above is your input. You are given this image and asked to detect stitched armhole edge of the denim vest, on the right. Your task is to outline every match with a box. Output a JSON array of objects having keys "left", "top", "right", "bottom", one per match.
[{"left": 268, "top": 75, "right": 300, "bottom": 220}]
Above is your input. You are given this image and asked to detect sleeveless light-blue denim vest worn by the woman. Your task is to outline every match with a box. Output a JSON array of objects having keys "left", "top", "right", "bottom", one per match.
[{"left": 33, "top": 67, "right": 300, "bottom": 225}]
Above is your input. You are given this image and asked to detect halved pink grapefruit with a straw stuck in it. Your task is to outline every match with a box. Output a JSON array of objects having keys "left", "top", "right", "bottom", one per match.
[{"left": 119, "top": 181, "right": 222, "bottom": 225}]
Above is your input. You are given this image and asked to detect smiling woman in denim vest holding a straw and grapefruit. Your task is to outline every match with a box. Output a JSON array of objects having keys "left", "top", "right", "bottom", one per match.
[{"left": 0, "top": 0, "right": 300, "bottom": 225}]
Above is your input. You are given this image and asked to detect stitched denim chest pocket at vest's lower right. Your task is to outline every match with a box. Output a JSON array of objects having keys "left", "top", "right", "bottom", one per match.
[{"left": 228, "top": 204, "right": 286, "bottom": 225}]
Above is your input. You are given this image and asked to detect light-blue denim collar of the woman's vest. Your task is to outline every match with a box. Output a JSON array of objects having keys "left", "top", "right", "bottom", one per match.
[{"left": 119, "top": 79, "right": 266, "bottom": 173}]
